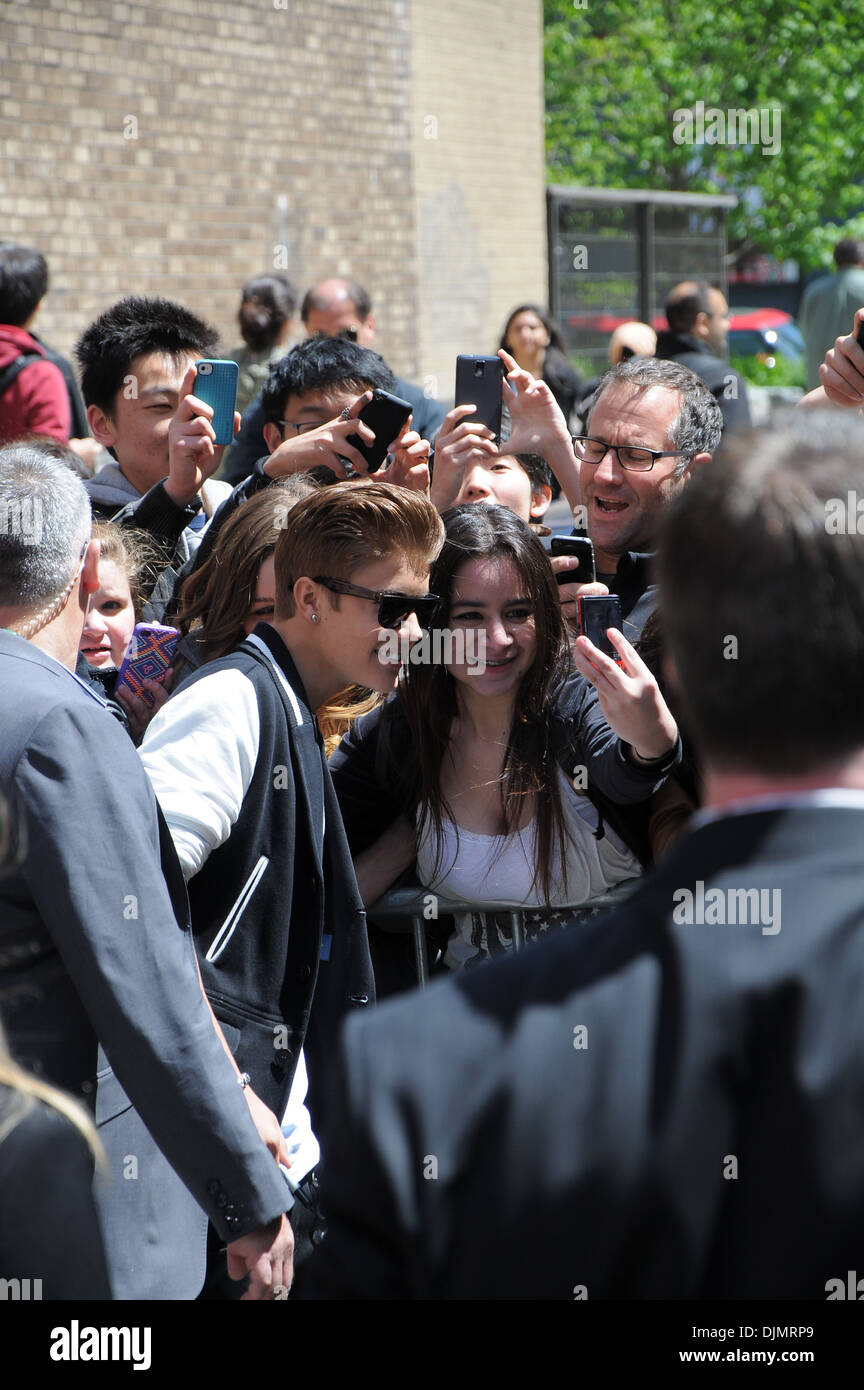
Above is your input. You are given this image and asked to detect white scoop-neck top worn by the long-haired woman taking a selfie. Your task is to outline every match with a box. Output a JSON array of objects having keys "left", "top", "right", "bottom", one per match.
[{"left": 417, "top": 770, "right": 642, "bottom": 969}]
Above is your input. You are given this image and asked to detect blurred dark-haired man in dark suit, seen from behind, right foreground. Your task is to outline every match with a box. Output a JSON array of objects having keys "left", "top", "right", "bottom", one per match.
[{"left": 310, "top": 411, "right": 864, "bottom": 1295}]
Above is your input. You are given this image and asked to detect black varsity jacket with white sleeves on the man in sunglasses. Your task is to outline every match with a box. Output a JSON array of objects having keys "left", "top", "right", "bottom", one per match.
[{"left": 140, "top": 623, "right": 374, "bottom": 1116}]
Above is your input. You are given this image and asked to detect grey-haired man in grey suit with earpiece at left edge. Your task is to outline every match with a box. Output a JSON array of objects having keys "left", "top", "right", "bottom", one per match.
[{"left": 0, "top": 443, "right": 292, "bottom": 1298}]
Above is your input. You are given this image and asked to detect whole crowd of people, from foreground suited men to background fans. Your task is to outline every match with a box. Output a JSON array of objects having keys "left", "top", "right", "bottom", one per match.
[{"left": 0, "top": 247, "right": 864, "bottom": 1300}]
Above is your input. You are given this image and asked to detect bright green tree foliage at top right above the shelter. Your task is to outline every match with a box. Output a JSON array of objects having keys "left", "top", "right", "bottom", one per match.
[{"left": 545, "top": 0, "right": 864, "bottom": 265}]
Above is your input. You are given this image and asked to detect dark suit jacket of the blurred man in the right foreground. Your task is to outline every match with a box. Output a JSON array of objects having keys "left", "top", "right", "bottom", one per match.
[{"left": 311, "top": 806, "right": 864, "bottom": 1300}]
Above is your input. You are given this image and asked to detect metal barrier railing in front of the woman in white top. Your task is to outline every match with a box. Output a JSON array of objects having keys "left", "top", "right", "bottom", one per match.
[{"left": 367, "top": 878, "right": 642, "bottom": 990}]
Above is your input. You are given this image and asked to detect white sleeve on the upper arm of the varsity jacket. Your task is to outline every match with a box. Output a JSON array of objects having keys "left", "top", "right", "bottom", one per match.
[{"left": 140, "top": 670, "right": 260, "bottom": 880}]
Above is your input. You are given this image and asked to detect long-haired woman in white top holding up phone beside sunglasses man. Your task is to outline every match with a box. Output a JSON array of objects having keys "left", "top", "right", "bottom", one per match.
[{"left": 331, "top": 506, "right": 679, "bottom": 967}]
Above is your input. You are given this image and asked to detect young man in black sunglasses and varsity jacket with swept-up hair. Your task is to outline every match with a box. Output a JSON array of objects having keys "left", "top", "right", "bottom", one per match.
[{"left": 140, "top": 480, "right": 443, "bottom": 1295}]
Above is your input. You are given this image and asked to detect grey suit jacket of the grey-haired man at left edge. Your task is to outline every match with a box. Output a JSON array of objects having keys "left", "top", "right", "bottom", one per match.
[{"left": 0, "top": 631, "right": 288, "bottom": 1295}]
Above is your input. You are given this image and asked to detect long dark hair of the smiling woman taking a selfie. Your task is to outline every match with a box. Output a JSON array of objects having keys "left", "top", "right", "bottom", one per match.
[{"left": 400, "top": 503, "right": 572, "bottom": 897}]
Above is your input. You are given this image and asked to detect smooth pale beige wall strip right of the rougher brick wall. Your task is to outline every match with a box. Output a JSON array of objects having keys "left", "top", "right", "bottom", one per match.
[{"left": 413, "top": 0, "right": 546, "bottom": 396}]
